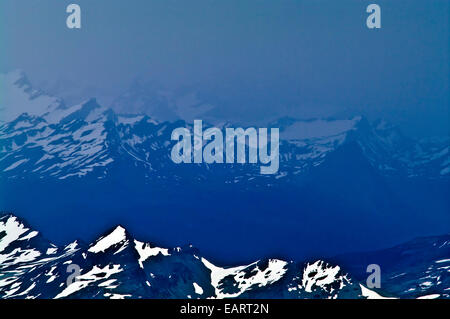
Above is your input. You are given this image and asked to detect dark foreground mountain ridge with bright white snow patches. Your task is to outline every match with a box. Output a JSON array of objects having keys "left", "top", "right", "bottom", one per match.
[{"left": 0, "top": 215, "right": 450, "bottom": 299}]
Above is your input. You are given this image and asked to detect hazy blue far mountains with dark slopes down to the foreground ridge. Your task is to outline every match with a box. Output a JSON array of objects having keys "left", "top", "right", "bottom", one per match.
[{"left": 0, "top": 72, "right": 450, "bottom": 258}]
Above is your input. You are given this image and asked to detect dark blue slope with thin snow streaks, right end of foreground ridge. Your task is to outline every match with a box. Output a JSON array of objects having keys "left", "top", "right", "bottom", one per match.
[{"left": 332, "top": 235, "right": 450, "bottom": 298}]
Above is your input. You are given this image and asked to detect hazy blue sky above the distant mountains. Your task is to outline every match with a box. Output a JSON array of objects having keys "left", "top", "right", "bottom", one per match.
[{"left": 0, "top": 0, "right": 450, "bottom": 135}]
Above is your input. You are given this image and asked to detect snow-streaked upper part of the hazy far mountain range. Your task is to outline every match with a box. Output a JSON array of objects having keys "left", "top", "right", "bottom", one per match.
[{"left": 0, "top": 72, "right": 450, "bottom": 184}]
